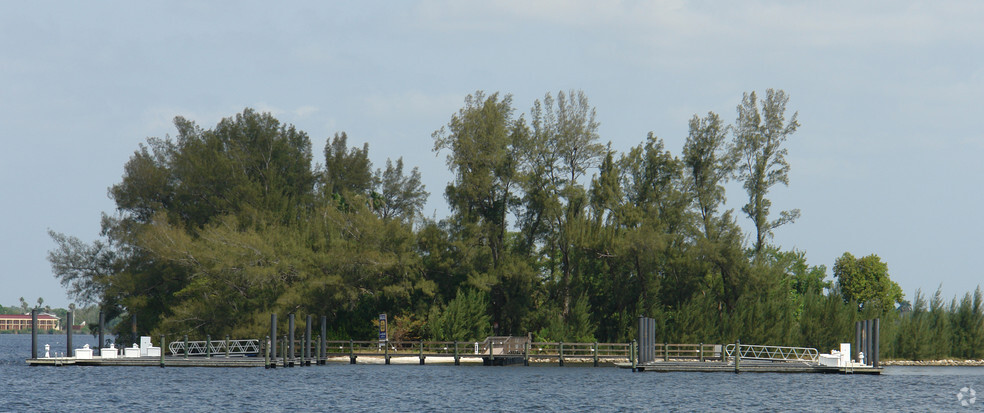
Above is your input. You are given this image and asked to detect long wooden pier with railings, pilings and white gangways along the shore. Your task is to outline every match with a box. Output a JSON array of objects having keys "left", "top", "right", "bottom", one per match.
[{"left": 26, "top": 313, "right": 882, "bottom": 374}]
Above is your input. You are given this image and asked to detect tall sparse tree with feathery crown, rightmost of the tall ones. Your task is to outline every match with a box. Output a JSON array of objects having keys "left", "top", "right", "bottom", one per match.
[{"left": 732, "top": 89, "right": 800, "bottom": 256}]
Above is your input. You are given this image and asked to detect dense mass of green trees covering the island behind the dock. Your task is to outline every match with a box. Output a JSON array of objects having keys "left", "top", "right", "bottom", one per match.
[{"left": 49, "top": 89, "right": 984, "bottom": 354}]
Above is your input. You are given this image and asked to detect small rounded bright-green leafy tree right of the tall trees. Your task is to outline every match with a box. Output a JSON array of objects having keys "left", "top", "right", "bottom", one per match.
[{"left": 834, "top": 252, "right": 902, "bottom": 312}]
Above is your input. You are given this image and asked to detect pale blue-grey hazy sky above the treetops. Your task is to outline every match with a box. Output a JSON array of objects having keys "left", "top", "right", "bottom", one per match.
[{"left": 0, "top": 0, "right": 984, "bottom": 307}]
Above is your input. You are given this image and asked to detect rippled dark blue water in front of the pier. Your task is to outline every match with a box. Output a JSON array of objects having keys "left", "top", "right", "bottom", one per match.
[{"left": 0, "top": 335, "right": 984, "bottom": 412}]
